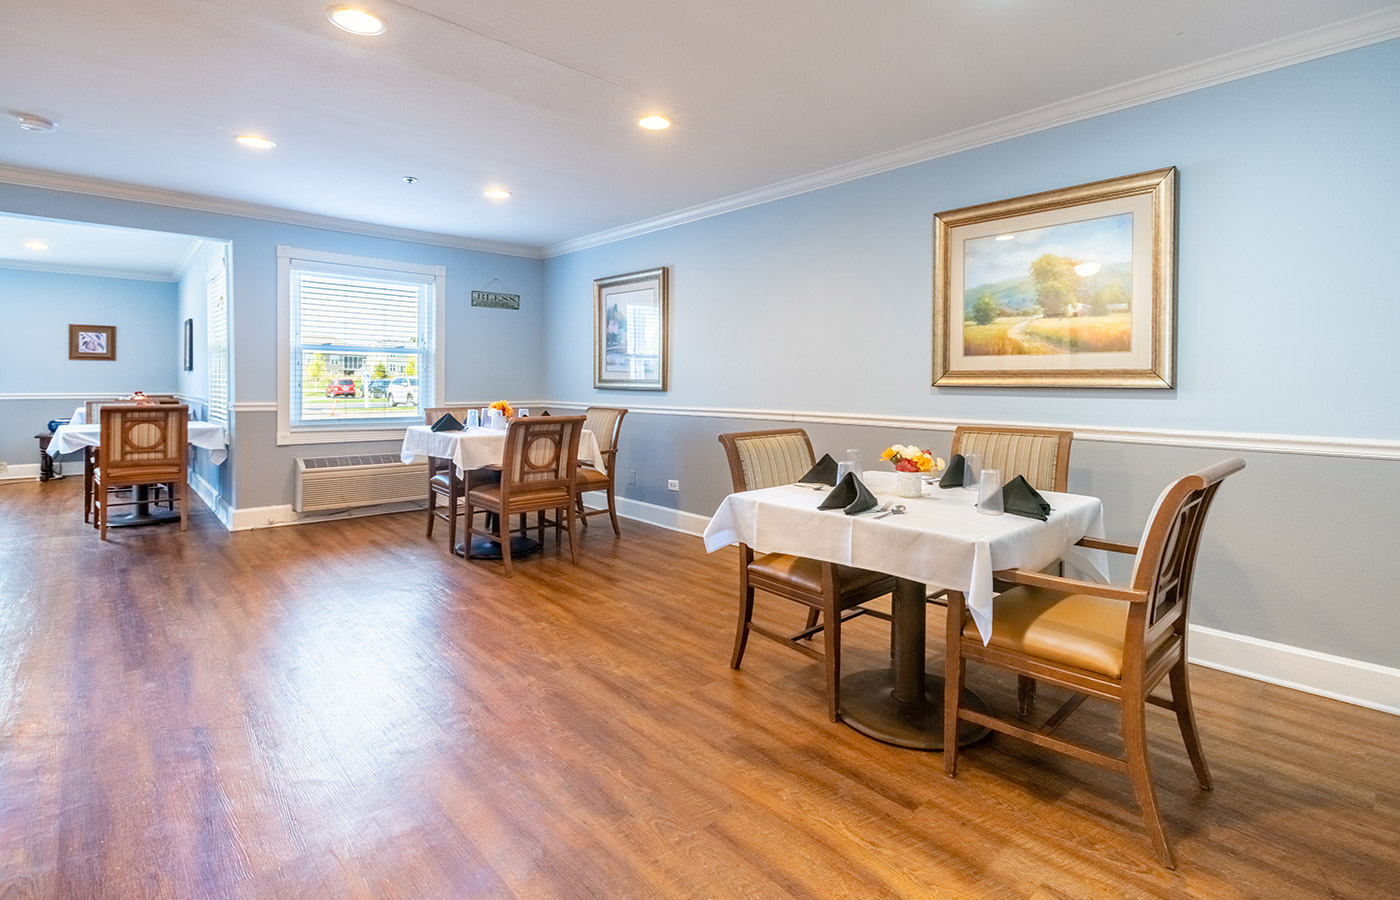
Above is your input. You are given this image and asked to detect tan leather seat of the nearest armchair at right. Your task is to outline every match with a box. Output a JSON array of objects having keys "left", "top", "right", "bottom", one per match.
[{"left": 963, "top": 586, "right": 1128, "bottom": 677}]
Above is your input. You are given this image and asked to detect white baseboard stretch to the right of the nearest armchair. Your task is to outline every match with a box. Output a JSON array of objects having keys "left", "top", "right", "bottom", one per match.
[{"left": 1190, "top": 626, "right": 1400, "bottom": 715}]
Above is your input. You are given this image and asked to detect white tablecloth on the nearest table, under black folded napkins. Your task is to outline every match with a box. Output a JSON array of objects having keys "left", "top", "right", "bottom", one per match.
[{"left": 704, "top": 472, "right": 1107, "bottom": 640}]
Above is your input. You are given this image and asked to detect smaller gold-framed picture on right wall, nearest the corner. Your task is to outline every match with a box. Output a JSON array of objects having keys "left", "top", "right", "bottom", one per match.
[{"left": 594, "top": 266, "right": 668, "bottom": 391}]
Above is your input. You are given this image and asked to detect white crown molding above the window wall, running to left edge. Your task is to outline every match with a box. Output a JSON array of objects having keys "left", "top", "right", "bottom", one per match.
[{"left": 0, "top": 165, "right": 543, "bottom": 259}]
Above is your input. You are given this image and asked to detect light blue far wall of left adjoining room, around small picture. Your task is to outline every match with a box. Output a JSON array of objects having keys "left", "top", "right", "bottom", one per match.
[{"left": 0, "top": 269, "right": 179, "bottom": 463}]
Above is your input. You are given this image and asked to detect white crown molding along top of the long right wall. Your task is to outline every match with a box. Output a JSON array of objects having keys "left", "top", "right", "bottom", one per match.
[{"left": 543, "top": 7, "right": 1400, "bottom": 259}]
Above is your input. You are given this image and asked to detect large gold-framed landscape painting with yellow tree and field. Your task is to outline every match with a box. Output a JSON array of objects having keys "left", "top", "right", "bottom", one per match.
[{"left": 934, "top": 168, "right": 1176, "bottom": 388}]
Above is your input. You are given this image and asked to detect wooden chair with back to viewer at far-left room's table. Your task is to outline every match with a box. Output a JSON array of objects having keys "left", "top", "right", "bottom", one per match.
[{"left": 92, "top": 403, "right": 189, "bottom": 540}]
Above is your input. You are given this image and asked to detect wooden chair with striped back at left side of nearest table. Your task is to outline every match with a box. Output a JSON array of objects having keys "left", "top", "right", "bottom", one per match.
[{"left": 720, "top": 428, "right": 895, "bottom": 722}]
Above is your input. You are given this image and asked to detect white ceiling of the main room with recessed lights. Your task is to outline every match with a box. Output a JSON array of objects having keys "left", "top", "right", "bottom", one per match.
[{"left": 0, "top": 0, "right": 1400, "bottom": 257}]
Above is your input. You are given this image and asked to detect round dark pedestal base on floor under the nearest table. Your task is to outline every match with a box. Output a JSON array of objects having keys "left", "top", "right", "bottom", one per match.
[{"left": 841, "top": 669, "right": 991, "bottom": 750}]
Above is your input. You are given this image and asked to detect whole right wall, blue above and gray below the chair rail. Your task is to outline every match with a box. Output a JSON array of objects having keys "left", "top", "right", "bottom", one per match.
[{"left": 545, "top": 42, "right": 1400, "bottom": 666}]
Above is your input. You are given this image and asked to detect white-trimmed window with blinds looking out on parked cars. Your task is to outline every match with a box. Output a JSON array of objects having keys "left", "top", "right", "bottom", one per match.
[{"left": 277, "top": 246, "right": 447, "bottom": 444}]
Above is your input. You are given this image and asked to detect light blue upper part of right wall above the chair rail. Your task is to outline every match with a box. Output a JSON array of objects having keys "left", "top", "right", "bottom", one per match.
[{"left": 546, "top": 42, "right": 1400, "bottom": 438}]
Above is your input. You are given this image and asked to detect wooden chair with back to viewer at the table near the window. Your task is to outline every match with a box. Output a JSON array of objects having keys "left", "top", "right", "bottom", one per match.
[{"left": 465, "top": 416, "right": 584, "bottom": 577}]
